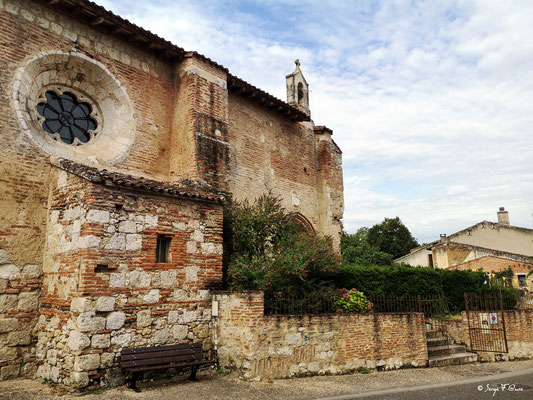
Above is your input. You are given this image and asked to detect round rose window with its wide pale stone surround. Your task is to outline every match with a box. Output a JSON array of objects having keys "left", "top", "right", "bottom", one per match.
[{"left": 12, "top": 51, "right": 135, "bottom": 165}]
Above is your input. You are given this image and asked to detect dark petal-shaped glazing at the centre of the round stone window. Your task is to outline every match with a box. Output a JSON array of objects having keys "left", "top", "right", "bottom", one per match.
[{"left": 37, "top": 90, "right": 97, "bottom": 145}]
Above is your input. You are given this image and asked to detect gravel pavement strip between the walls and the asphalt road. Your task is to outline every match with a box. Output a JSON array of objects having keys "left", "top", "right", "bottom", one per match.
[{"left": 0, "top": 360, "right": 533, "bottom": 400}]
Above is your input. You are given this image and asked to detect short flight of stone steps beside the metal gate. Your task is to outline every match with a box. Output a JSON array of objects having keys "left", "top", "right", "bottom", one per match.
[{"left": 426, "top": 331, "right": 477, "bottom": 367}]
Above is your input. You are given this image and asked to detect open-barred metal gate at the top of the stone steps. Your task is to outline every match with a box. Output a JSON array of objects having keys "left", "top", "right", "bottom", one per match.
[{"left": 465, "top": 293, "right": 508, "bottom": 353}]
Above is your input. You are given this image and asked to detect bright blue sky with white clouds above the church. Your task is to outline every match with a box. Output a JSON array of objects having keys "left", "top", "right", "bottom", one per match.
[{"left": 92, "top": 0, "right": 533, "bottom": 243}]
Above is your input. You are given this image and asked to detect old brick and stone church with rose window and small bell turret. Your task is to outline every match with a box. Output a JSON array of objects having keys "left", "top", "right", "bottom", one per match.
[{"left": 0, "top": 0, "right": 343, "bottom": 387}]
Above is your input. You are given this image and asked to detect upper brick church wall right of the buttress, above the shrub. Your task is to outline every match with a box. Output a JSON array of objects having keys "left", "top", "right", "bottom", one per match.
[{"left": 227, "top": 93, "right": 344, "bottom": 249}]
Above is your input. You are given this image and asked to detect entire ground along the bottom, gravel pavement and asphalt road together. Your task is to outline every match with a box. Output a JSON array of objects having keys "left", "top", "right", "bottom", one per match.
[{"left": 0, "top": 360, "right": 533, "bottom": 400}]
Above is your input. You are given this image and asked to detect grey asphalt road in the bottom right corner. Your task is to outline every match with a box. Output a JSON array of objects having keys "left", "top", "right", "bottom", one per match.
[{"left": 316, "top": 368, "right": 533, "bottom": 400}]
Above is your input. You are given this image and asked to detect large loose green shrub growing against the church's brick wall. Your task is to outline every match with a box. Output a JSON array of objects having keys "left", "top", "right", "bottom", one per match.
[{"left": 225, "top": 194, "right": 339, "bottom": 294}]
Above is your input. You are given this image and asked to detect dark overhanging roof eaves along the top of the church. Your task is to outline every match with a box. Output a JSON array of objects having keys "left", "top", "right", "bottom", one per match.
[{"left": 33, "top": 0, "right": 310, "bottom": 121}]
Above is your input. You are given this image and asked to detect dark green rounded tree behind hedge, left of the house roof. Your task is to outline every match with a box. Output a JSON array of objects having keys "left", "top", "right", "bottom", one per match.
[{"left": 366, "top": 217, "right": 418, "bottom": 258}]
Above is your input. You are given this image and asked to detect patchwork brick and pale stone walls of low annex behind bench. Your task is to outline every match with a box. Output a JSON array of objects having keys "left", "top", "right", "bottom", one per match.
[{"left": 32, "top": 169, "right": 222, "bottom": 387}]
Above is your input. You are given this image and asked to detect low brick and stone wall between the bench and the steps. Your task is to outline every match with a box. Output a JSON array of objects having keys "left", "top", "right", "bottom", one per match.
[{"left": 213, "top": 292, "right": 428, "bottom": 379}]
